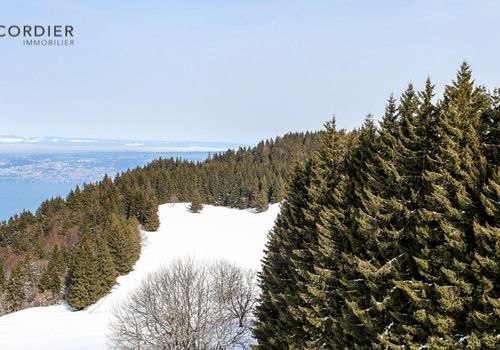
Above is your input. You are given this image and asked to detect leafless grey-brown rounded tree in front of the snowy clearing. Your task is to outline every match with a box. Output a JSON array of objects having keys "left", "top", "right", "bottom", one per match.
[{"left": 110, "top": 259, "right": 258, "bottom": 350}]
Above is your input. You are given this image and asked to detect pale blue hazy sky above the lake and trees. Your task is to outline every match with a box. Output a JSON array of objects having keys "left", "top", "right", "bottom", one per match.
[{"left": 0, "top": 0, "right": 500, "bottom": 143}]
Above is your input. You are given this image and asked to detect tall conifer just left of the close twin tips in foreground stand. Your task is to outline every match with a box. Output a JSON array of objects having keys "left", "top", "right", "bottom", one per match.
[{"left": 360, "top": 95, "right": 414, "bottom": 349}]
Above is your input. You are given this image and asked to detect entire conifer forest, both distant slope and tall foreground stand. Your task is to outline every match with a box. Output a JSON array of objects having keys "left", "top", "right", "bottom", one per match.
[{"left": 0, "top": 62, "right": 500, "bottom": 350}]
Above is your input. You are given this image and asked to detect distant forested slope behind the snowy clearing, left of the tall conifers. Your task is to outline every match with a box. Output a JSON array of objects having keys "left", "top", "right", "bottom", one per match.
[{"left": 0, "top": 133, "right": 318, "bottom": 314}]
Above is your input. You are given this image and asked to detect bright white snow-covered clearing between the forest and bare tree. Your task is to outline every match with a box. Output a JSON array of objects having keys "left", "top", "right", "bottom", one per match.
[{"left": 0, "top": 204, "right": 279, "bottom": 350}]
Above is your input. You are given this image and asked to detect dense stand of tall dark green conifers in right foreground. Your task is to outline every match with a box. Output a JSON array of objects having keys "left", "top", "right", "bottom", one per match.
[{"left": 254, "top": 63, "right": 500, "bottom": 350}]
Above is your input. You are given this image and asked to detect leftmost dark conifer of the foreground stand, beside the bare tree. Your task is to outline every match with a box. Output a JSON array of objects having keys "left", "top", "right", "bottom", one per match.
[{"left": 254, "top": 163, "right": 312, "bottom": 349}]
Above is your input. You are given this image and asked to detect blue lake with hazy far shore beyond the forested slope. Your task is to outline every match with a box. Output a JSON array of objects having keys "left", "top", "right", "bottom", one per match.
[{"left": 0, "top": 152, "right": 209, "bottom": 220}]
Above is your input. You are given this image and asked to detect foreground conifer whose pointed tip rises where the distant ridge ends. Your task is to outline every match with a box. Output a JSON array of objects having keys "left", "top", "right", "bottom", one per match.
[{"left": 301, "top": 120, "right": 350, "bottom": 349}]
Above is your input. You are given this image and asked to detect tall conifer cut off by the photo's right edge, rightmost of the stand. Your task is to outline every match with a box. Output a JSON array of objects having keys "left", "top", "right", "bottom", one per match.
[{"left": 468, "top": 89, "right": 500, "bottom": 349}]
